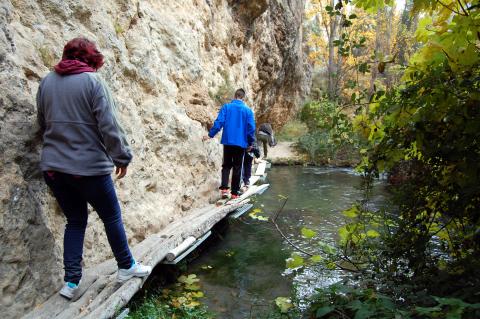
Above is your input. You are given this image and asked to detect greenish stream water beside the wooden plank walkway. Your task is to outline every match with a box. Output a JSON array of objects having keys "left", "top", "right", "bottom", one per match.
[{"left": 188, "top": 167, "right": 385, "bottom": 319}]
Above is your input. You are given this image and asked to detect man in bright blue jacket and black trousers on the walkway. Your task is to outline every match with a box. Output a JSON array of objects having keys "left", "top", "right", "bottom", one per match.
[{"left": 204, "top": 89, "right": 255, "bottom": 199}]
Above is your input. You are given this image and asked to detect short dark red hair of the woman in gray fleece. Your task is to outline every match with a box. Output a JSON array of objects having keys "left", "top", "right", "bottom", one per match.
[{"left": 62, "top": 38, "right": 104, "bottom": 70}]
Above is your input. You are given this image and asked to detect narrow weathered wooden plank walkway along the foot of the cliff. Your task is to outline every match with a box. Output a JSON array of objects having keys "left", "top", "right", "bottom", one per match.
[{"left": 23, "top": 165, "right": 268, "bottom": 319}]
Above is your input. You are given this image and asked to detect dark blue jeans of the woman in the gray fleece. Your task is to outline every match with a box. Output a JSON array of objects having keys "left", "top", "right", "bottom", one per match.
[{"left": 43, "top": 172, "right": 133, "bottom": 284}]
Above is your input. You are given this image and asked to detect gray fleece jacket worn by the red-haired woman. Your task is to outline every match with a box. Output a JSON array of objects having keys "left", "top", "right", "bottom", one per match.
[{"left": 37, "top": 72, "right": 132, "bottom": 176}]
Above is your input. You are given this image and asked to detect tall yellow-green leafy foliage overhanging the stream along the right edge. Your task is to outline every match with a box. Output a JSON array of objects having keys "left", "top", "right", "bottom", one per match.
[{"left": 341, "top": 0, "right": 480, "bottom": 304}]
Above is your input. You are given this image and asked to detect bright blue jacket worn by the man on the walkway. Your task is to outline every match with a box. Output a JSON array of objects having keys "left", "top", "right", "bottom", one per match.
[{"left": 208, "top": 100, "right": 255, "bottom": 148}]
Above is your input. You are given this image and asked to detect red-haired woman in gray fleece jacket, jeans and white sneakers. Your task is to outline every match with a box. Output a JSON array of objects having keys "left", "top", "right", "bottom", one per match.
[{"left": 37, "top": 38, "right": 152, "bottom": 299}]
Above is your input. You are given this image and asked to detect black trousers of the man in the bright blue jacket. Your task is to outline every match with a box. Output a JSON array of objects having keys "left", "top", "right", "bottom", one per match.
[{"left": 220, "top": 145, "right": 245, "bottom": 195}]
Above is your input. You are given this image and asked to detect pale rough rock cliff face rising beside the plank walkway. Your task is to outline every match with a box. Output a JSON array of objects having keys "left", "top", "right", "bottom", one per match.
[{"left": 0, "top": 0, "right": 308, "bottom": 318}]
